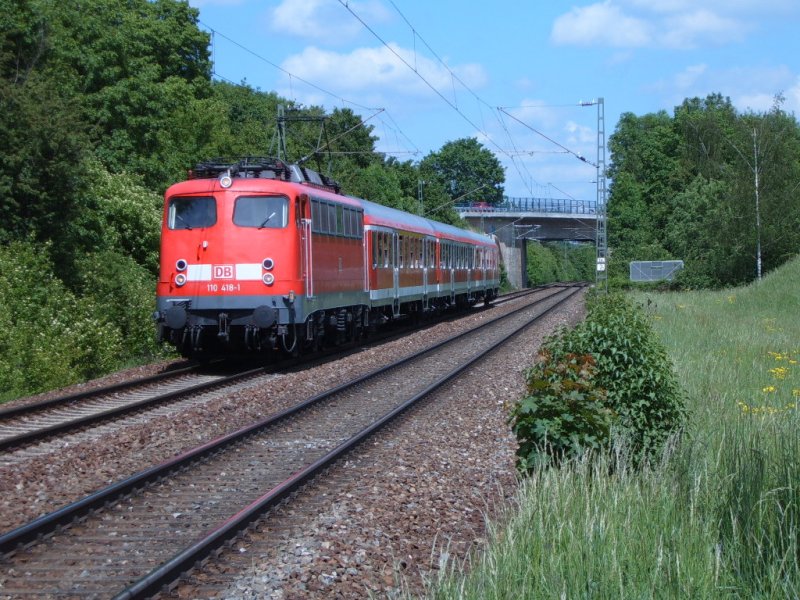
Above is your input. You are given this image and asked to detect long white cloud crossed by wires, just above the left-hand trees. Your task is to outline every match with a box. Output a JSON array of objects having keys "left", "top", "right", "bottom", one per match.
[{"left": 281, "top": 44, "right": 487, "bottom": 100}]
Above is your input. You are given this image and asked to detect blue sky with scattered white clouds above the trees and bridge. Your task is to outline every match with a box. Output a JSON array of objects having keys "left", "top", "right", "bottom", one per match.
[{"left": 190, "top": 0, "right": 800, "bottom": 200}]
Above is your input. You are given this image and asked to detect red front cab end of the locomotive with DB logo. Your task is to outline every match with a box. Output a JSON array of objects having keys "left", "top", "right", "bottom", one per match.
[{"left": 154, "top": 159, "right": 320, "bottom": 356}]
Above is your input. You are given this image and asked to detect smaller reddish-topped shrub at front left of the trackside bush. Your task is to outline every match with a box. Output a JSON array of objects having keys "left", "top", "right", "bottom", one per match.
[{"left": 511, "top": 349, "right": 613, "bottom": 471}]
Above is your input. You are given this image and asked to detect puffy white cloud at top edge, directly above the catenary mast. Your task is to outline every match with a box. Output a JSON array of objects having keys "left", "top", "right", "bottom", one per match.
[{"left": 551, "top": 0, "right": 652, "bottom": 48}]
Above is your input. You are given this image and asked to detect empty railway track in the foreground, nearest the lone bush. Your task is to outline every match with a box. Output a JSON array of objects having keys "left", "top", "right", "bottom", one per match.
[{"left": 0, "top": 288, "right": 577, "bottom": 598}]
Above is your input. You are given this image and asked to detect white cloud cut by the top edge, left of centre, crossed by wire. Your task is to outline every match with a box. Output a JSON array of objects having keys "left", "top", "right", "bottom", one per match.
[{"left": 270, "top": 0, "right": 388, "bottom": 44}]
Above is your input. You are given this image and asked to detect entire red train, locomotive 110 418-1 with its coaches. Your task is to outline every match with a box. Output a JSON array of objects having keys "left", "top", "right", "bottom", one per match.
[{"left": 154, "top": 158, "right": 500, "bottom": 356}]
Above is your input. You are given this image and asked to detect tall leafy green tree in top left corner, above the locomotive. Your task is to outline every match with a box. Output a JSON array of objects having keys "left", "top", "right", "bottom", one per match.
[{"left": 0, "top": 0, "right": 211, "bottom": 188}]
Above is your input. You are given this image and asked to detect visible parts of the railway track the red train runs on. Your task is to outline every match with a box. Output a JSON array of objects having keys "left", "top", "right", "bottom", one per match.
[{"left": 0, "top": 286, "right": 557, "bottom": 452}]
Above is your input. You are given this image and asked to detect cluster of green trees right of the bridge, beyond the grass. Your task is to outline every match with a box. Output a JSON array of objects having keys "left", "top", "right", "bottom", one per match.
[{"left": 608, "top": 94, "right": 800, "bottom": 286}]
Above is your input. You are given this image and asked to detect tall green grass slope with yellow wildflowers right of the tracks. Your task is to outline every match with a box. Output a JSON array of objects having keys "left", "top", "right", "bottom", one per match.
[{"left": 430, "top": 260, "right": 800, "bottom": 600}]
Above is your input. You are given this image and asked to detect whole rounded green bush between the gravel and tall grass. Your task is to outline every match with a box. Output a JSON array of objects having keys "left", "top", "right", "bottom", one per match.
[{"left": 511, "top": 294, "right": 685, "bottom": 470}]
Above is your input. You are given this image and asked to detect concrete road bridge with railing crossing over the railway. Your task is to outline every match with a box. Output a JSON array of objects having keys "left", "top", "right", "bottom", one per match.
[{"left": 455, "top": 197, "right": 597, "bottom": 288}]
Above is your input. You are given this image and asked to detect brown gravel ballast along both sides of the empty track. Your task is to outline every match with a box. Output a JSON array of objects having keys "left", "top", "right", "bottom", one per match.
[{"left": 0, "top": 293, "right": 584, "bottom": 598}]
